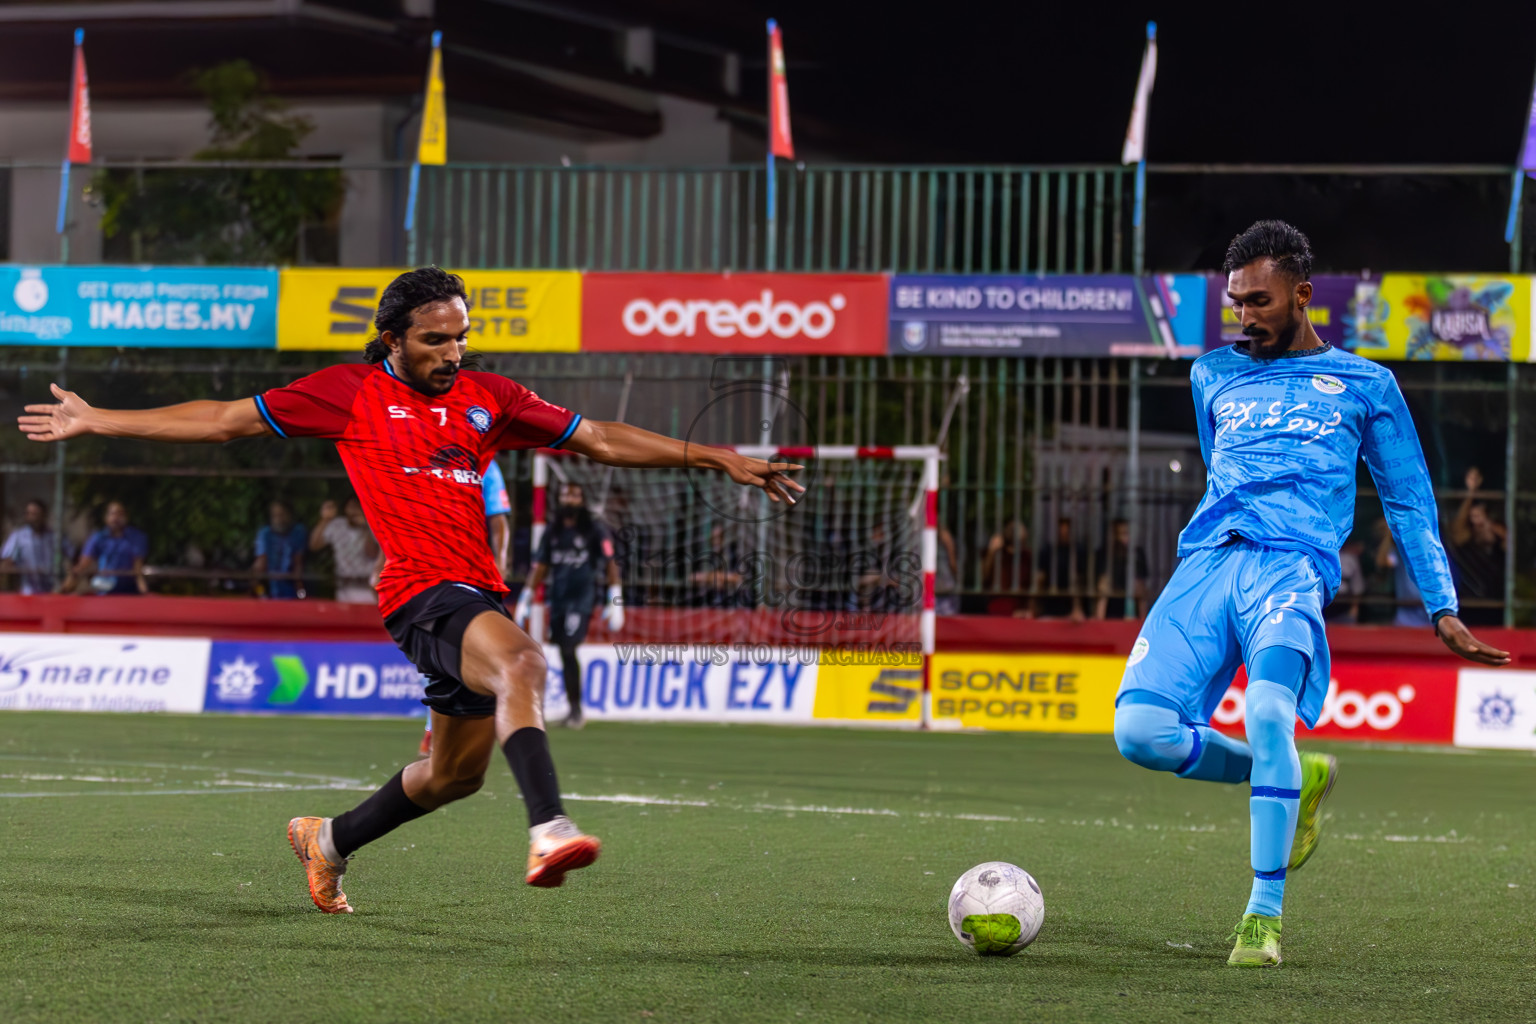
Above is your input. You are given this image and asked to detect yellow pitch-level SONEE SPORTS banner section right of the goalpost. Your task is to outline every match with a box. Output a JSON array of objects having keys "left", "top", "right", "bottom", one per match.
[{"left": 921, "top": 654, "right": 1126, "bottom": 732}]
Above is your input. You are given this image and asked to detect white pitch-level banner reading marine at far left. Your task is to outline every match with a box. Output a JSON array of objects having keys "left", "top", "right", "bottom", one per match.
[{"left": 0, "top": 633, "right": 209, "bottom": 712}]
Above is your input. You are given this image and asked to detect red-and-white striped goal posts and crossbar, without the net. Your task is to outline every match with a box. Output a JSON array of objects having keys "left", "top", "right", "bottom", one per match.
[{"left": 528, "top": 444, "right": 943, "bottom": 728}]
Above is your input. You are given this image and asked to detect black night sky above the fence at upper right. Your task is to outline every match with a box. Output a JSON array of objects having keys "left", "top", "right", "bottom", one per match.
[{"left": 721, "top": 0, "right": 1536, "bottom": 163}]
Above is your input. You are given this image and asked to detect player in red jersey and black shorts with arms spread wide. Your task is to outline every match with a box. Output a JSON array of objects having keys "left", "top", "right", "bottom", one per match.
[{"left": 18, "top": 267, "right": 803, "bottom": 913}]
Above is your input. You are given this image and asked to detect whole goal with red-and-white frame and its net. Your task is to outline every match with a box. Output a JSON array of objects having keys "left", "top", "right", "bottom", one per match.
[{"left": 530, "top": 445, "right": 943, "bottom": 728}]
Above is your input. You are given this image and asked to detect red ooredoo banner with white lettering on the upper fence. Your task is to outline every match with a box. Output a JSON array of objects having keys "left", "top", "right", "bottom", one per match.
[{"left": 581, "top": 273, "right": 886, "bottom": 356}]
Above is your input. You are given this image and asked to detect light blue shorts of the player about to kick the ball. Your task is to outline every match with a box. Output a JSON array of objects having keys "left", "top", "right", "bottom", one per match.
[{"left": 1115, "top": 540, "right": 1329, "bottom": 729}]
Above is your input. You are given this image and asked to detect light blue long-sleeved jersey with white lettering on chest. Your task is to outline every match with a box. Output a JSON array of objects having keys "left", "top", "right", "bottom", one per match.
[{"left": 1178, "top": 344, "right": 1456, "bottom": 616}]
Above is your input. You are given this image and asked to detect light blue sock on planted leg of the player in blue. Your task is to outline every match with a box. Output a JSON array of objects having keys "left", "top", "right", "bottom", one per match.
[{"left": 1247, "top": 675, "right": 1301, "bottom": 917}]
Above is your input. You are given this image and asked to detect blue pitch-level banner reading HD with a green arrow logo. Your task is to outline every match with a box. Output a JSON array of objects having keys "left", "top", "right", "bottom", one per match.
[{"left": 203, "top": 640, "right": 427, "bottom": 717}]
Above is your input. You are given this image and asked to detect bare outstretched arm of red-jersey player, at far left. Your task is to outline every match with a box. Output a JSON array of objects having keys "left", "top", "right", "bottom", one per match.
[{"left": 17, "top": 384, "right": 270, "bottom": 444}]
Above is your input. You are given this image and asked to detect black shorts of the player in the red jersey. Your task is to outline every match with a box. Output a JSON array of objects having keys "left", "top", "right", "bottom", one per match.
[{"left": 384, "top": 583, "right": 511, "bottom": 718}]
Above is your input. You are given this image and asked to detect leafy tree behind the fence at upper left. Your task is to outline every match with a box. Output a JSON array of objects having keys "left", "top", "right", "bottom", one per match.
[{"left": 94, "top": 60, "right": 346, "bottom": 264}]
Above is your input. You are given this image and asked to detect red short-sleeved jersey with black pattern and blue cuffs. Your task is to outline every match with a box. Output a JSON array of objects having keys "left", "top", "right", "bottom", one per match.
[{"left": 257, "top": 364, "right": 581, "bottom": 617}]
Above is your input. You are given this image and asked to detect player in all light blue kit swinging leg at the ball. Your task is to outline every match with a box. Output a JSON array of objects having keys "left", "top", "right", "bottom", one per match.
[{"left": 1115, "top": 221, "right": 1508, "bottom": 967}]
